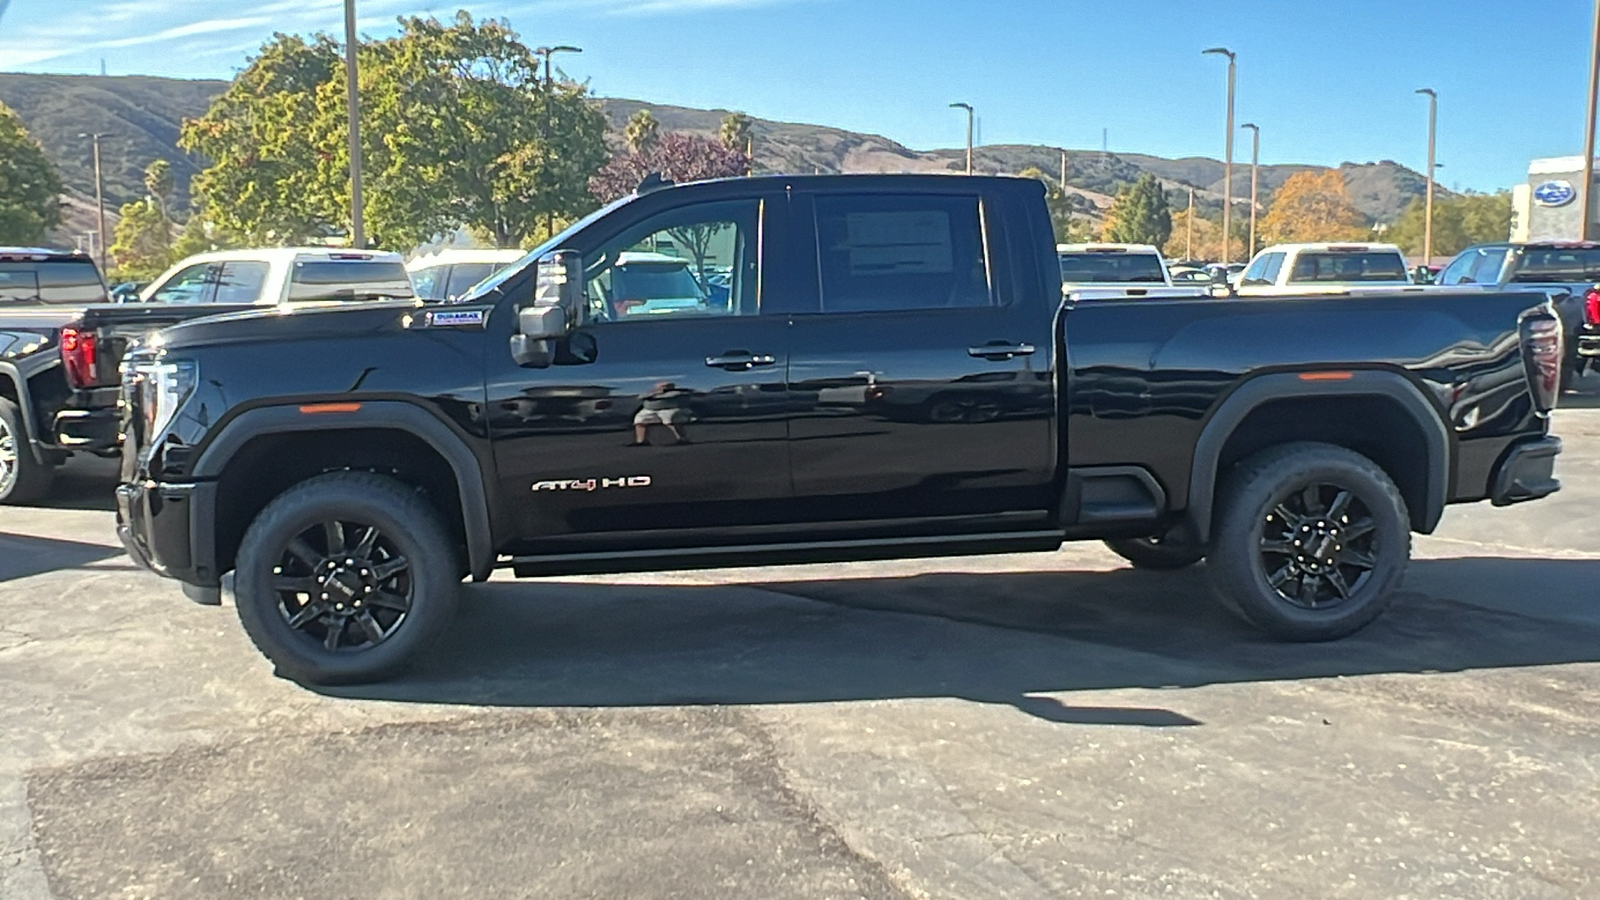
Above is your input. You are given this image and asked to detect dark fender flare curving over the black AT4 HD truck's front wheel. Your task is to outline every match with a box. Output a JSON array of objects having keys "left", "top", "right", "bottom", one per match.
[{"left": 192, "top": 400, "right": 494, "bottom": 581}]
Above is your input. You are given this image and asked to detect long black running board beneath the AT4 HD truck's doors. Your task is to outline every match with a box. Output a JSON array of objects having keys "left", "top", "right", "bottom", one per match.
[{"left": 510, "top": 530, "right": 1064, "bottom": 578}]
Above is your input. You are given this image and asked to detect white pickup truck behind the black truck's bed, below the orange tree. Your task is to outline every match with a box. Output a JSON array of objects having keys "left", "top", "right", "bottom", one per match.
[{"left": 1238, "top": 243, "right": 1413, "bottom": 296}]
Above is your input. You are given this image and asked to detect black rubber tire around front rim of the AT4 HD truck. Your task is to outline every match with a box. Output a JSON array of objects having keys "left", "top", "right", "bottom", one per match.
[{"left": 234, "top": 472, "right": 461, "bottom": 684}]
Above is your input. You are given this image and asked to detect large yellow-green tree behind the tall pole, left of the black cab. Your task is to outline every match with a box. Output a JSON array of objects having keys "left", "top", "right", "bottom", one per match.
[{"left": 182, "top": 11, "right": 606, "bottom": 250}]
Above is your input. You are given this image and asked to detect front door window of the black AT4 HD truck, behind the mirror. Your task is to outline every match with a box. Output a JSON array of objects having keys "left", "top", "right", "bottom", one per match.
[{"left": 584, "top": 199, "right": 762, "bottom": 322}]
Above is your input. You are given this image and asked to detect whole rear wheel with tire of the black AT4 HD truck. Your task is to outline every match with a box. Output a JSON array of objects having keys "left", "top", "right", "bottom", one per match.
[{"left": 1206, "top": 444, "right": 1411, "bottom": 641}]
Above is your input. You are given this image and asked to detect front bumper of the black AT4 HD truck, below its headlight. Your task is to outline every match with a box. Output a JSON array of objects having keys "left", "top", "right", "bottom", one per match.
[{"left": 117, "top": 480, "right": 221, "bottom": 592}]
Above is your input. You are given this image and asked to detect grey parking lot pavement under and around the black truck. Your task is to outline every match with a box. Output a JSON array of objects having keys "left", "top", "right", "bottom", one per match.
[{"left": 0, "top": 408, "right": 1600, "bottom": 900}]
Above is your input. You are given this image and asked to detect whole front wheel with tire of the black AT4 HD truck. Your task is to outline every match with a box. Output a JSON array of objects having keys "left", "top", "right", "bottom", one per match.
[{"left": 234, "top": 472, "right": 461, "bottom": 684}]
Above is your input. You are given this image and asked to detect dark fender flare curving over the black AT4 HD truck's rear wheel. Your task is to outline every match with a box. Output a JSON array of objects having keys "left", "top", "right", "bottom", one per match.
[{"left": 1187, "top": 370, "right": 1451, "bottom": 543}]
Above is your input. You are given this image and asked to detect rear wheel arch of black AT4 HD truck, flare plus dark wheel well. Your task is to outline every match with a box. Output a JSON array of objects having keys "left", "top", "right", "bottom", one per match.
[{"left": 1187, "top": 370, "right": 1453, "bottom": 543}]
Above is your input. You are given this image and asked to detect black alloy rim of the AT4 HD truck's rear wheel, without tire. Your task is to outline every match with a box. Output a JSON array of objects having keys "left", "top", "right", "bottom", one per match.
[{"left": 1261, "top": 484, "right": 1378, "bottom": 610}]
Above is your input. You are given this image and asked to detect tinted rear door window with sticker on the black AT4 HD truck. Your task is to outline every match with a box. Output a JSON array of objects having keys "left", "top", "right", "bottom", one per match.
[{"left": 816, "top": 194, "right": 995, "bottom": 312}]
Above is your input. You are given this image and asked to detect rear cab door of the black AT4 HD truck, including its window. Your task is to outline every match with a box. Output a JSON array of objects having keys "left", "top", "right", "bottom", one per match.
[{"left": 789, "top": 188, "right": 1059, "bottom": 530}]
